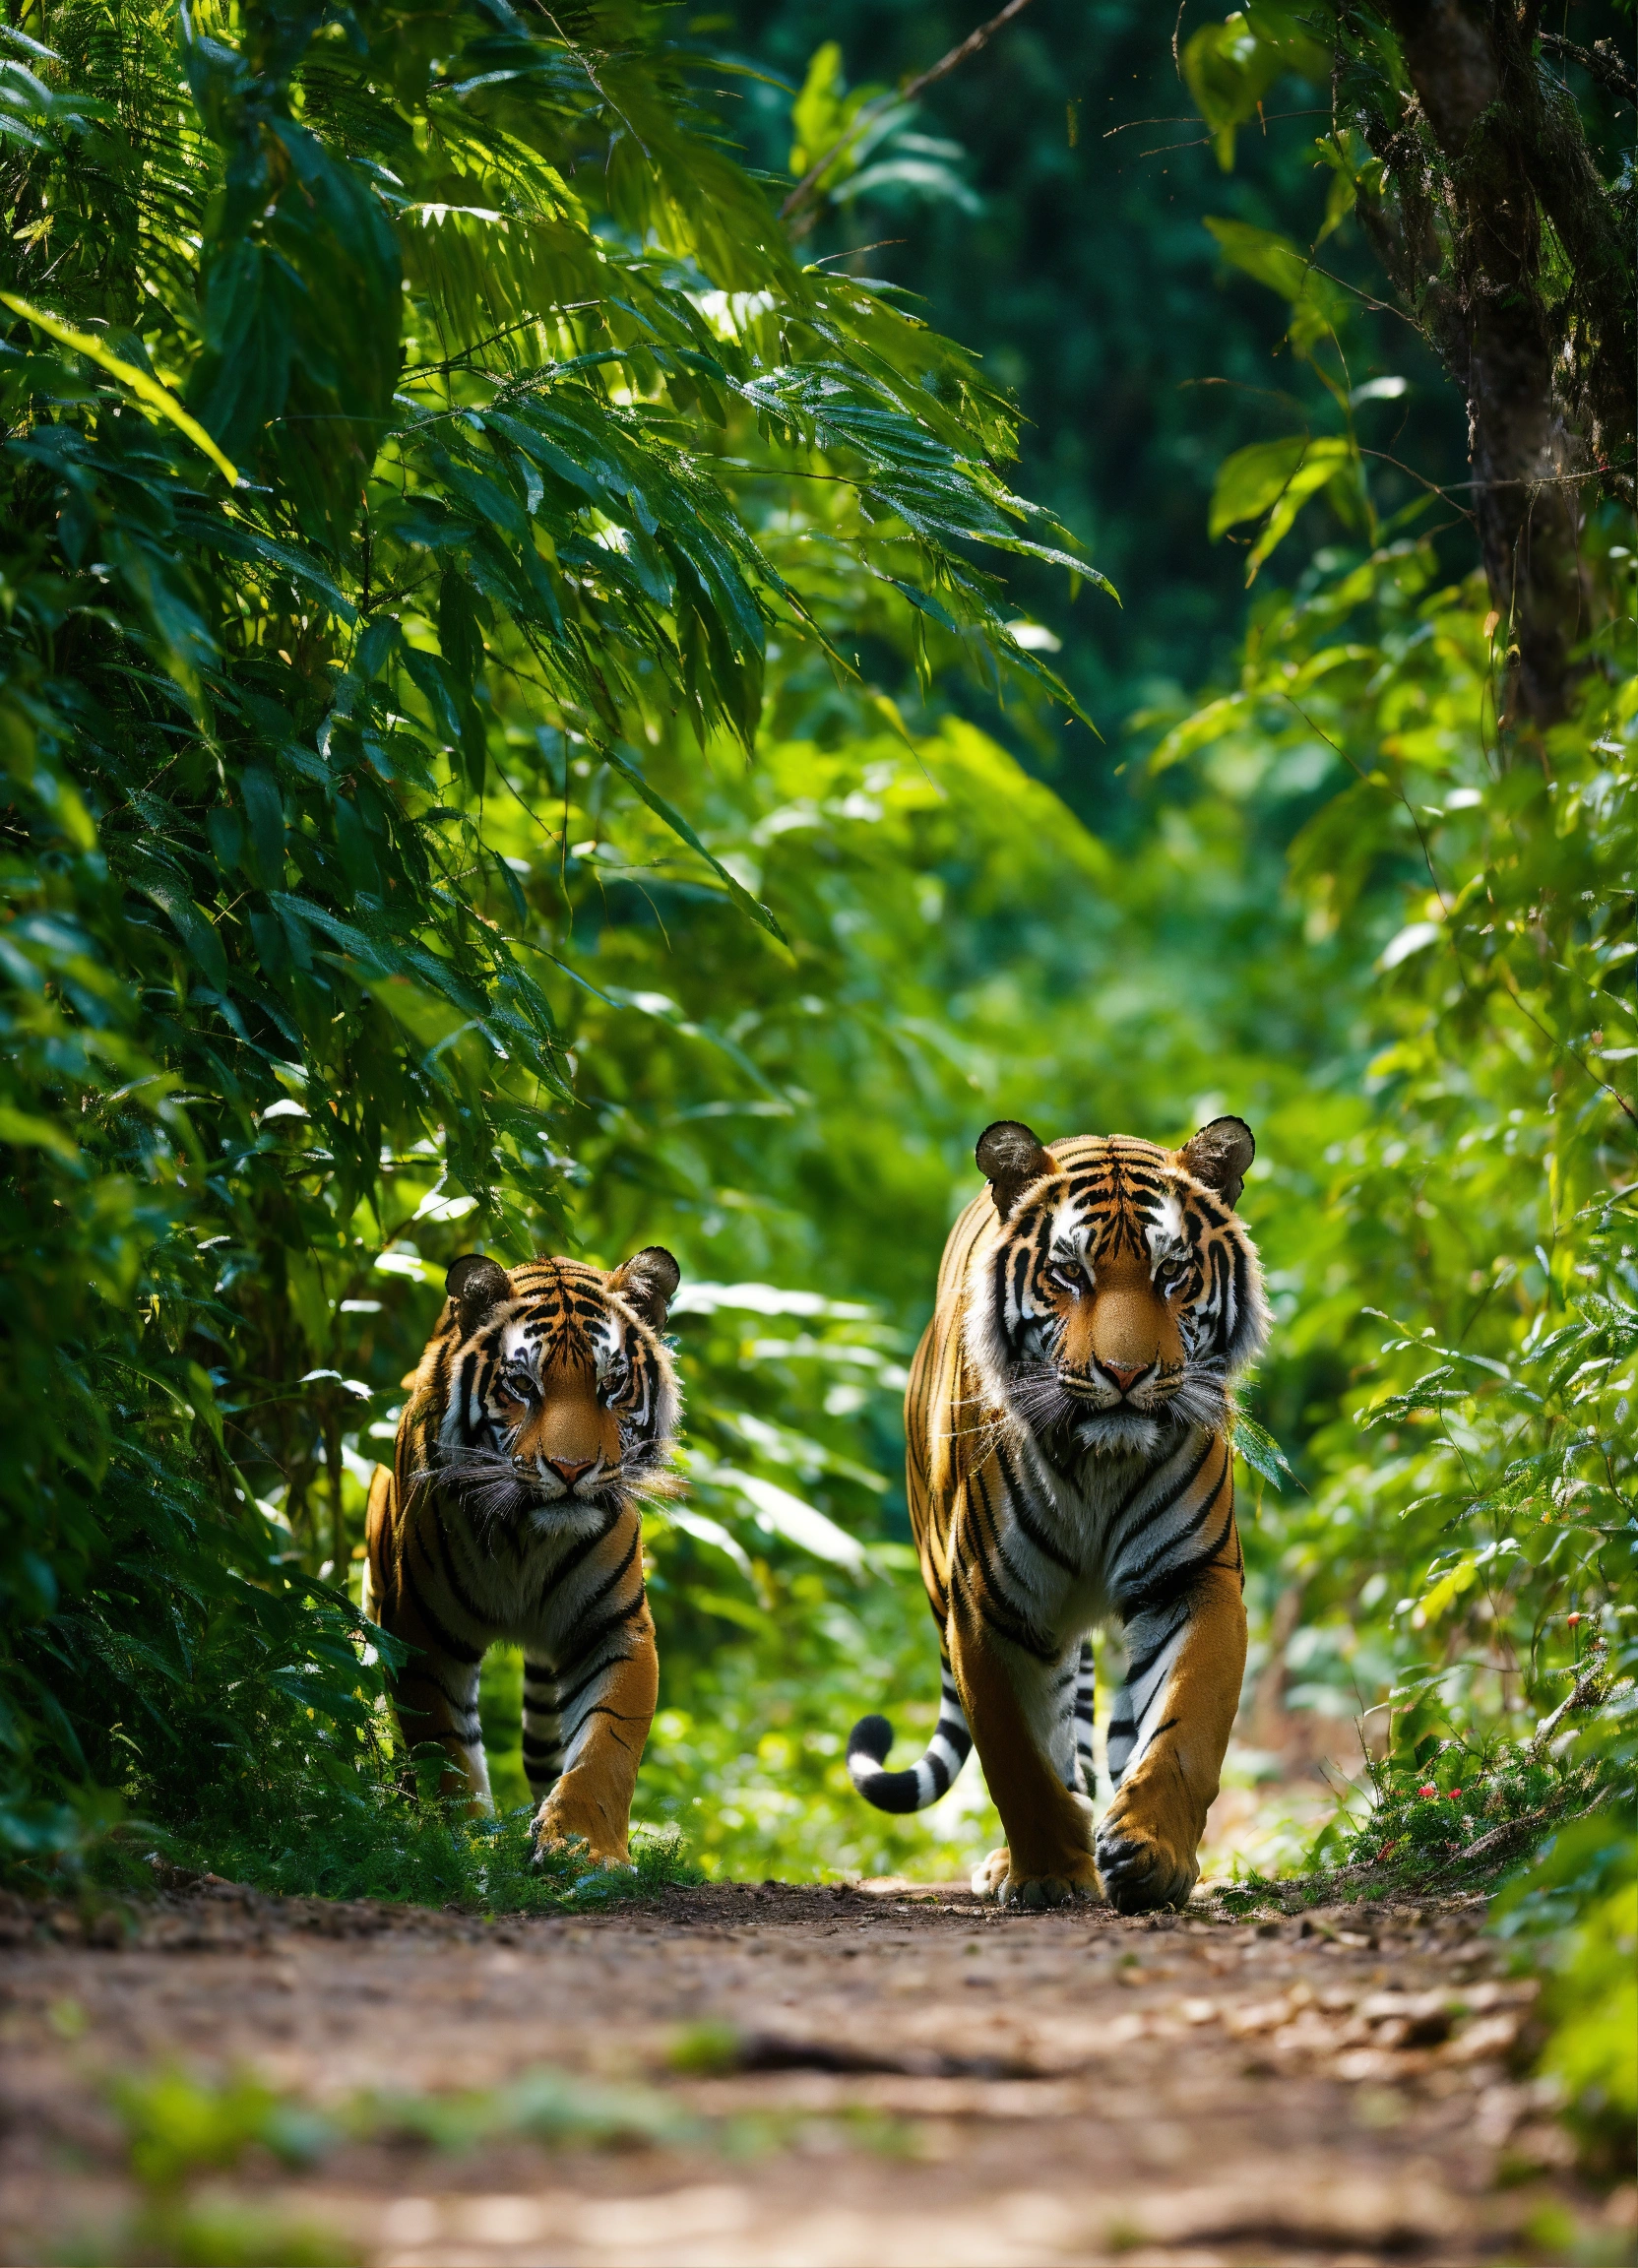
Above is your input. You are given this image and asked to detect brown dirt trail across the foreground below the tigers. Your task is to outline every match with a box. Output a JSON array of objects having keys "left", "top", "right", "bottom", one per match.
[{"left": 0, "top": 1882, "right": 1626, "bottom": 2268}]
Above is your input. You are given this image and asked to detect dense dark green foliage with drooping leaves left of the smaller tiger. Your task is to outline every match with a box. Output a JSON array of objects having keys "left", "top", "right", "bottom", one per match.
[{"left": 0, "top": 0, "right": 1098, "bottom": 1849}]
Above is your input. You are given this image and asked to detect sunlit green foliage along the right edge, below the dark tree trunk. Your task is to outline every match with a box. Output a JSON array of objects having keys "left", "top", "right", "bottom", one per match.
[{"left": 1155, "top": 0, "right": 1638, "bottom": 2173}]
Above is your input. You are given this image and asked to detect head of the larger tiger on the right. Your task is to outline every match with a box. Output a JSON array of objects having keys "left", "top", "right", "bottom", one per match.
[{"left": 969, "top": 1118, "right": 1268, "bottom": 1456}]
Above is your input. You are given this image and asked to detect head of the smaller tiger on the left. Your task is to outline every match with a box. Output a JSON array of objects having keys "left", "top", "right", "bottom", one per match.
[{"left": 422, "top": 1245, "right": 680, "bottom": 1520}]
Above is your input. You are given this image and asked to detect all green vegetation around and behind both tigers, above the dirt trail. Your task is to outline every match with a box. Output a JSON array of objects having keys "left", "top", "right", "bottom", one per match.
[{"left": 0, "top": 0, "right": 1638, "bottom": 2168}]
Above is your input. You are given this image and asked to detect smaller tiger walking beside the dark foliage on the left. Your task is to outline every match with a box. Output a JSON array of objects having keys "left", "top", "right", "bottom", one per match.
[{"left": 363, "top": 1245, "right": 680, "bottom": 1866}]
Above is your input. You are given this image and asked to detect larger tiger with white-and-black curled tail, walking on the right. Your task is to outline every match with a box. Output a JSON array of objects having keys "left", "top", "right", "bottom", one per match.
[{"left": 849, "top": 1118, "right": 1268, "bottom": 1915}]
